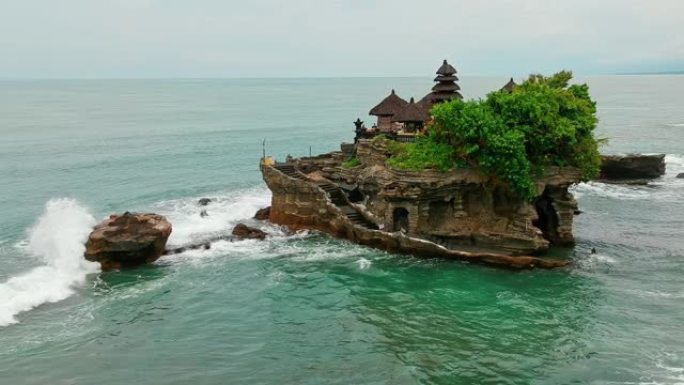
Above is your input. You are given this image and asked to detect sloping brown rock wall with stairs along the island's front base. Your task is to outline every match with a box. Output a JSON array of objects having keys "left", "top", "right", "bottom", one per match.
[{"left": 261, "top": 159, "right": 567, "bottom": 268}]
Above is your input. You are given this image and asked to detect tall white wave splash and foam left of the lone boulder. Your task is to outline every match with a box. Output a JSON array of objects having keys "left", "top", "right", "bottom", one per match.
[{"left": 0, "top": 199, "right": 99, "bottom": 326}]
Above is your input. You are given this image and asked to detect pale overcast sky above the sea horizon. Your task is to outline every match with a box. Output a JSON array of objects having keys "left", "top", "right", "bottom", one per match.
[{"left": 0, "top": 0, "right": 684, "bottom": 79}]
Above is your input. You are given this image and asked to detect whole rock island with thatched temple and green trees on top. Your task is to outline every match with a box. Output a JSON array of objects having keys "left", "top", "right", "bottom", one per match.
[{"left": 261, "top": 60, "right": 656, "bottom": 268}]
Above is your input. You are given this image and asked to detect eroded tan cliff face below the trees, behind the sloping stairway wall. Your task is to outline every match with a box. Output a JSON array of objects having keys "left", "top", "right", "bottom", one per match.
[{"left": 347, "top": 140, "right": 580, "bottom": 254}]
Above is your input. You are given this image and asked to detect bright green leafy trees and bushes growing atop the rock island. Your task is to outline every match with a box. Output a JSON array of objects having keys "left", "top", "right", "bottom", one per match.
[{"left": 389, "top": 71, "right": 600, "bottom": 199}]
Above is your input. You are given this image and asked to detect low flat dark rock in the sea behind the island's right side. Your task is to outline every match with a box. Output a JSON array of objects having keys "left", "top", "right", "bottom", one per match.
[{"left": 600, "top": 154, "right": 665, "bottom": 180}]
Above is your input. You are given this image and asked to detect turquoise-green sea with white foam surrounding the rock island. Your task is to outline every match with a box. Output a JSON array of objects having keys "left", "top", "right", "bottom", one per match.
[{"left": 0, "top": 76, "right": 684, "bottom": 385}]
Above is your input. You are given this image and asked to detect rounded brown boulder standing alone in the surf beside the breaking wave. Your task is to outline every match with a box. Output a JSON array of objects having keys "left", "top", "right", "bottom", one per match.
[{"left": 85, "top": 212, "right": 171, "bottom": 270}]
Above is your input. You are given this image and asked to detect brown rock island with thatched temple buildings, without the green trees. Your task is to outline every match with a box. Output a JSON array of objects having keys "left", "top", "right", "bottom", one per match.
[{"left": 261, "top": 60, "right": 580, "bottom": 268}]
